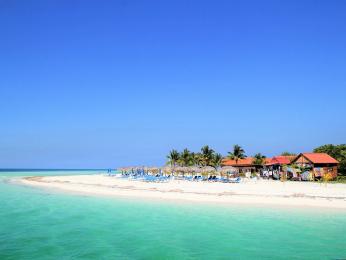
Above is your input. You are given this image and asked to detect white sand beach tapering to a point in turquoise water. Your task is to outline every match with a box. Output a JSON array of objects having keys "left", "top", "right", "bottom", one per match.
[{"left": 21, "top": 174, "right": 346, "bottom": 209}]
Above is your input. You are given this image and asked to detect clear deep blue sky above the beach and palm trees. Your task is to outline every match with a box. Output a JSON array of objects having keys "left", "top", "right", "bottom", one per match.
[{"left": 0, "top": 0, "right": 346, "bottom": 168}]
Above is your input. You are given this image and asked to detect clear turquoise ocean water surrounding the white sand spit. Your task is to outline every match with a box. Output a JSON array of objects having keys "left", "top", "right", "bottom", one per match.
[{"left": 0, "top": 171, "right": 346, "bottom": 260}]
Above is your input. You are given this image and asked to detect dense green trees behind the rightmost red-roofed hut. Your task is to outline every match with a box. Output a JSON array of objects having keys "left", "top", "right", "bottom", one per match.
[{"left": 314, "top": 144, "right": 346, "bottom": 176}]
